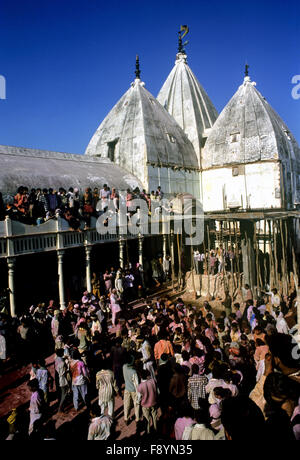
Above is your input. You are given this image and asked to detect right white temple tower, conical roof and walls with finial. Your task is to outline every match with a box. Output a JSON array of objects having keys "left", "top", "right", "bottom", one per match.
[{"left": 202, "top": 66, "right": 300, "bottom": 211}]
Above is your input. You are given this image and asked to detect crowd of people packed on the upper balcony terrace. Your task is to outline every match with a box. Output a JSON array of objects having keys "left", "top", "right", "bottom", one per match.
[{"left": 0, "top": 184, "right": 163, "bottom": 230}]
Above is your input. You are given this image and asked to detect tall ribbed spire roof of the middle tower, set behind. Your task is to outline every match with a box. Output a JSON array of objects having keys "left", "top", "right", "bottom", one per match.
[{"left": 157, "top": 52, "right": 218, "bottom": 163}]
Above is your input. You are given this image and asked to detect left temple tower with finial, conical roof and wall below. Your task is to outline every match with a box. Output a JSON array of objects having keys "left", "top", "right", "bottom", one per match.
[{"left": 85, "top": 56, "right": 199, "bottom": 197}]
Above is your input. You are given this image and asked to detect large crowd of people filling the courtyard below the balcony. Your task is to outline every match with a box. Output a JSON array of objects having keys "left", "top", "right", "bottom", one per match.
[{"left": 0, "top": 273, "right": 300, "bottom": 442}]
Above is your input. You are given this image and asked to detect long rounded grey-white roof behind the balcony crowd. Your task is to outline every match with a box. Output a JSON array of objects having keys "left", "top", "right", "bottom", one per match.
[{"left": 0, "top": 145, "right": 142, "bottom": 196}]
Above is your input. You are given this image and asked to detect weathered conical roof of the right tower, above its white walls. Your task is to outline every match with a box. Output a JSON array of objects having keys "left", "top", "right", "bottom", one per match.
[{"left": 202, "top": 74, "right": 300, "bottom": 169}]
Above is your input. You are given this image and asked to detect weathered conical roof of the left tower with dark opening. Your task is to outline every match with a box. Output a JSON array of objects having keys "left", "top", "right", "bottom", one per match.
[{"left": 85, "top": 78, "right": 198, "bottom": 177}]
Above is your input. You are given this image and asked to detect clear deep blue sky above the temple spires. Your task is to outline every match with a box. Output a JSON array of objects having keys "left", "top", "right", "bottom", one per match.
[{"left": 0, "top": 0, "right": 300, "bottom": 153}]
